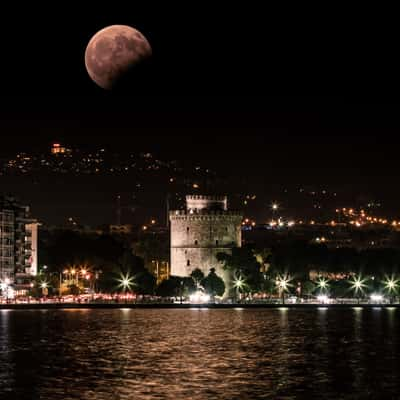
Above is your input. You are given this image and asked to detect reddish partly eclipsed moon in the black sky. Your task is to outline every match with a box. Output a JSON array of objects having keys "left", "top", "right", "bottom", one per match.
[{"left": 85, "top": 25, "right": 152, "bottom": 90}]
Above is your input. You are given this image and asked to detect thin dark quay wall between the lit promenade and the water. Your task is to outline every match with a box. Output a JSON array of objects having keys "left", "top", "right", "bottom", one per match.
[{"left": 0, "top": 303, "right": 400, "bottom": 310}]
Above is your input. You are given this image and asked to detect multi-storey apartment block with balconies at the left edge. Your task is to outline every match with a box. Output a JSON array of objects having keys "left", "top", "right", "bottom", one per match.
[{"left": 0, "top": 196, "right": 39, "bottom": 290}]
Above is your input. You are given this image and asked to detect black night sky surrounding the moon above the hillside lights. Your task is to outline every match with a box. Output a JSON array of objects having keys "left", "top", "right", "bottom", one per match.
[{"left": 0, "top": 4, "right": 400, "bottom": 223}]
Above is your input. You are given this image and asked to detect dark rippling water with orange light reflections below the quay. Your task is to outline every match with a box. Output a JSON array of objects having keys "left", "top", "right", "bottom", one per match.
[{"left": 0, "top": 308, "right": 400, "bottom": 400}]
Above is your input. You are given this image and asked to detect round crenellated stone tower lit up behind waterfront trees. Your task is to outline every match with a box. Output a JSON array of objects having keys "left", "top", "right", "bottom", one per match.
[{"left": 170, "top": 195, "right": 242, "bottom": 276}]
